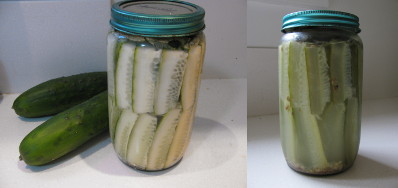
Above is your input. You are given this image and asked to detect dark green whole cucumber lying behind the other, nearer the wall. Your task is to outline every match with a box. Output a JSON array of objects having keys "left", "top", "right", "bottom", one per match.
[{"left": 12, "top": 72, "right": 107, "bottom": 118}]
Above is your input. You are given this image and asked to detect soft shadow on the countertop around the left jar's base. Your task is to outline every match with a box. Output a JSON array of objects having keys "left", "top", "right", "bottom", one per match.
[{"left": 80, "top": 117, "right": 238, "bottom": 178}]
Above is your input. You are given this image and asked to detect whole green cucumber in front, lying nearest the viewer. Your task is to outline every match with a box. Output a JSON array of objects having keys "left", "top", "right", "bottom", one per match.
[{"left": 19, "top": 91, "right": 109, "bottom": 166}]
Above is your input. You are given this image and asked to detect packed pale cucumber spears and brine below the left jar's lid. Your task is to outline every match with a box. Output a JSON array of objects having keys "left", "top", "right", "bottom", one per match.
[{"left": 107, "top": 31, "right": 206, "bottom": 171}]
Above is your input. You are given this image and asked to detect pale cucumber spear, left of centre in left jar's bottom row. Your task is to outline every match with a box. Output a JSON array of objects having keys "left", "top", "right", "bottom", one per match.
[{"left": 126, "top": 114, "right": 157, "bottom": 169}]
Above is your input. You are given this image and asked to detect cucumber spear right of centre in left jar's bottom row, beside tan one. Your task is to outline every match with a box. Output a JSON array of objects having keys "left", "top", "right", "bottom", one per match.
[{"left": 146, "top": 108, "right": 181, "bottom": 170}]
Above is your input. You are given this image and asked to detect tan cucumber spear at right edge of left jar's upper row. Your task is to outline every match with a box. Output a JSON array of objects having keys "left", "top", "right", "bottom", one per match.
[{"left": 181, "top": 45, "right": 202, "bottom": 110}]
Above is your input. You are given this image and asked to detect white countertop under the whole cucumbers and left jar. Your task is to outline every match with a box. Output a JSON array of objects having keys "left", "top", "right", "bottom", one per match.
[{"left": 0, "top": 79, "right": 247, "bottom": 188}]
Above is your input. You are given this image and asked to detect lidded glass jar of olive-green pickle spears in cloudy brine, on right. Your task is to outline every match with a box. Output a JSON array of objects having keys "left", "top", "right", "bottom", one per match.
[{"left": 279, "top": 10, "right": 363, "bottom": 175}]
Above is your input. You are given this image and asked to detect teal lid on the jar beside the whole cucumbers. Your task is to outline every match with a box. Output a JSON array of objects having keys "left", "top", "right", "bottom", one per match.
[{"left": 110, "top": 0, "right": 205, "bottom": 37}]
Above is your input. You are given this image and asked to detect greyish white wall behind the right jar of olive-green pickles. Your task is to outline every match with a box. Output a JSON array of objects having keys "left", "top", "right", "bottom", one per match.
[{"left": 247, "top": 0, "right": 398, "bottom": 116}]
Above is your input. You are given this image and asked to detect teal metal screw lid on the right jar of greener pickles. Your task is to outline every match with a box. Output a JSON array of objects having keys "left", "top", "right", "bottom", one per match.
[{"left": 282, "top": 10, "right": 361, "bottom": 33}]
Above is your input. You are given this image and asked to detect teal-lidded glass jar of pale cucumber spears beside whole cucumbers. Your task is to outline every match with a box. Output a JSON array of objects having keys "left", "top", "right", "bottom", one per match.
[{"left": 107, "top": 0, "right": 206, "bottom": 171}]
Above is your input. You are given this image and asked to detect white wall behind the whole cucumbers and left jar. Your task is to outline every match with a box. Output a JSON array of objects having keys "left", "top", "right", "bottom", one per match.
[{"left": 0, "top": 0, "right": 247, "bottom": 93}]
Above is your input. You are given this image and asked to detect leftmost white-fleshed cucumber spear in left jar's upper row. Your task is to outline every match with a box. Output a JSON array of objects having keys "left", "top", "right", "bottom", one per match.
[{"left": 115, "top": 43, "right": 136, "bottom": 109}]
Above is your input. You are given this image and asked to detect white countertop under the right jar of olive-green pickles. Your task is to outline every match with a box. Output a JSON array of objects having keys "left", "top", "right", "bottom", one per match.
[{"left": 247, "top": 98, "right": 398, "bottom": 188}]
